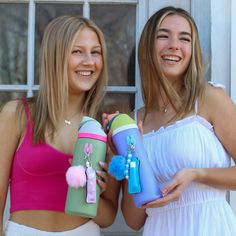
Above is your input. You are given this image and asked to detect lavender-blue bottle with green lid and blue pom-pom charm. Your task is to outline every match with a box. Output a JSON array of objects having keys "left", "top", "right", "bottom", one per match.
[{"left": 108, "top": 114, "right": 162, "bottom": 207}]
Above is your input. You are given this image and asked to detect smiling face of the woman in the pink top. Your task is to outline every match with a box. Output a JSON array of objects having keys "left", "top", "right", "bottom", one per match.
[{"left": 68, "top": 27, "right": 103, "bottom": 95}]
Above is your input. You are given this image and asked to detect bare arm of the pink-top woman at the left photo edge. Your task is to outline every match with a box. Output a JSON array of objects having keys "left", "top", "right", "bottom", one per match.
[{"left": 0, "top": 102, "right": 20, "bottom": 235}]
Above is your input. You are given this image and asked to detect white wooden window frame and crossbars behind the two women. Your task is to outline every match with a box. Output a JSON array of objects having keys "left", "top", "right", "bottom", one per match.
[{"left": 0, "top": 0, "right": 147, "bottom": 107}]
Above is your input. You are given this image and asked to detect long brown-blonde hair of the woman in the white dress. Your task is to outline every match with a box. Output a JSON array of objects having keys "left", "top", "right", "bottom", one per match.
[{"left": 138, "top": 7, "right": 205, "bottom": 120}]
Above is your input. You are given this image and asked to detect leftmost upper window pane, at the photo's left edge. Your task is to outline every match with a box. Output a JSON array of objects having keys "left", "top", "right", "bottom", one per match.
[{"left": 0, "top": 3, "right": 28, "bottom": 84}]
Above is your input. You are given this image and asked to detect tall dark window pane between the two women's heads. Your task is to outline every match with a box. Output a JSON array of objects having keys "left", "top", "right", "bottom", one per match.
[{"left": 90, "top": 4, "right": 136, "bottom": 86}]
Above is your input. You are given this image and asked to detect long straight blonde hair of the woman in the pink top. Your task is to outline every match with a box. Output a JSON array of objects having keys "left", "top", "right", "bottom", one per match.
[{"left": 27, "top": 16, "right": 108, "bottom": 143}]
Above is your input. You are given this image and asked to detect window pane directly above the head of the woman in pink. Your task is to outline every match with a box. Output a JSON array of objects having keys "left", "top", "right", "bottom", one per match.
[{"left": 35, "top": 4, "right": 83, "bottom": 84}]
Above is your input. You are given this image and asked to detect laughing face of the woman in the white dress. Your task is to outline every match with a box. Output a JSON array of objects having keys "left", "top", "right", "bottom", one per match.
[{"left": 155, "top": 15, "right": 192, "bottom": 82}]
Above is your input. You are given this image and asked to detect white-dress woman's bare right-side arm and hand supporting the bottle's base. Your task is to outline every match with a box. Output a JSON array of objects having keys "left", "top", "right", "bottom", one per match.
[{"left": 146, "top": 85, "right": 236, "bottom": 207}]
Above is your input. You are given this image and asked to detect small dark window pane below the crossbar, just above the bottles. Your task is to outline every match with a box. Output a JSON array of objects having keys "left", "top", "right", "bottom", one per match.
[{"left": 101, "top": 93, "right": 135, "bottom": 113}]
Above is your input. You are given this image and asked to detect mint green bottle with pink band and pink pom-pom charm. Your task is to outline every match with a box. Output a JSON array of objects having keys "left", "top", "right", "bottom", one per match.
[{"left": 65, "top": 116, "right": 107, "bottom": 218}]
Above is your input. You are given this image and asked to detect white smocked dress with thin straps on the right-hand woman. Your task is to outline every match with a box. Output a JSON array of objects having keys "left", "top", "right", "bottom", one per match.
[{"left": 135, "top": 84, "right": 236, "bottom": 236}]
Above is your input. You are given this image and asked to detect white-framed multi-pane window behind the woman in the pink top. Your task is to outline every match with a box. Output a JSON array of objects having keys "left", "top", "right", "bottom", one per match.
[{"left": 0, "top": 0, "right": 139, "bottom": 112}]
